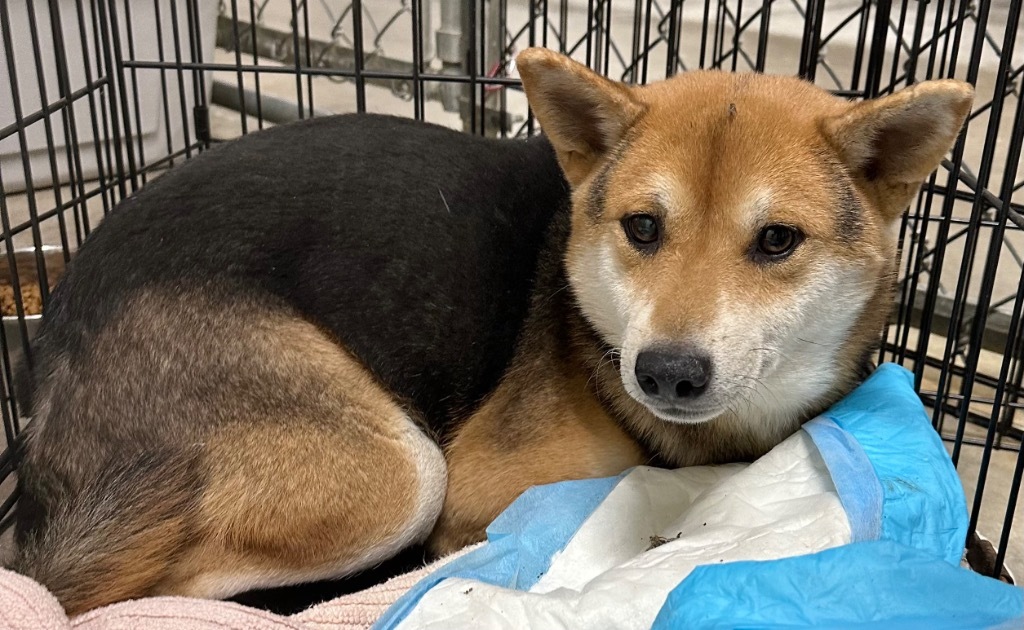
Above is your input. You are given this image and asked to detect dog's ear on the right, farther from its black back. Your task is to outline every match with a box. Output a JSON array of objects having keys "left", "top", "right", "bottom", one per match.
[{"left": 822, "top": 79, "right": 974, "bottom": 220}]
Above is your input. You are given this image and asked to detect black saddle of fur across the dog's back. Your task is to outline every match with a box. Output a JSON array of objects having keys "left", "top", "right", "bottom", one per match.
[{"left": 24, "top": 115, "right": 569, "bottom": 429}]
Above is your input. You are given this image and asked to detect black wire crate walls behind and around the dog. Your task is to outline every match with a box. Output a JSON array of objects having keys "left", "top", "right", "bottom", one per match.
[{"left": 0, "top": 0, "right": 1024, "bottom": 575}]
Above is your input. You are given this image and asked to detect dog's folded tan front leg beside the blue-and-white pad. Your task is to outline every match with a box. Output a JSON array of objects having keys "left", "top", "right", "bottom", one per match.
[{"left": 429, "top": 348, "right": 646, "bottom": 554}]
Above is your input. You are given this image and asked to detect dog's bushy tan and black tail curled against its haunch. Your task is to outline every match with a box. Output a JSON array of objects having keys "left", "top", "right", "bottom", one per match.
[{"left": 10, "top": 454, "right": 200, "bottom": 617}]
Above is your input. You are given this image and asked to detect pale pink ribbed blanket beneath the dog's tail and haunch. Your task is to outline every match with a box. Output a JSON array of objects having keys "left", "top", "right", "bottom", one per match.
[{"left": 0, "top": 546, "right": 475, "bottom": 630}]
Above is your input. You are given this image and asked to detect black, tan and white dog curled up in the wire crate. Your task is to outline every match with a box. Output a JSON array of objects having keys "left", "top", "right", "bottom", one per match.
[{"left": 13, "top": 49, "right": 973, "bottom": 615}]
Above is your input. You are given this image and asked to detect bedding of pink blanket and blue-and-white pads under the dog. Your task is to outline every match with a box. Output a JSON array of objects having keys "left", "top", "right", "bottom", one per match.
[{"left": 0, "top": 365, "right": 1024, "bottom": 630}]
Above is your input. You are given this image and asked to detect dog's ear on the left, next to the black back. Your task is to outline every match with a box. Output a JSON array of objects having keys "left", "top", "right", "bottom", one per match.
[{"left": 516, "top": 48, "right": 644, "bottom": 187}]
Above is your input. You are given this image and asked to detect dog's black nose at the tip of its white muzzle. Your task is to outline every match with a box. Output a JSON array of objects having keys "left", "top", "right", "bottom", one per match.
[{"left": 635, "top": 348, "right": 711, "bottom": 403}]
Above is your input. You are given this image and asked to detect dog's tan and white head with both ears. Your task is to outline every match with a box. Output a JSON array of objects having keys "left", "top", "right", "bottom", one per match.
[{"left": 517, "top": 48, "right": 973, "bottom": 432}]
